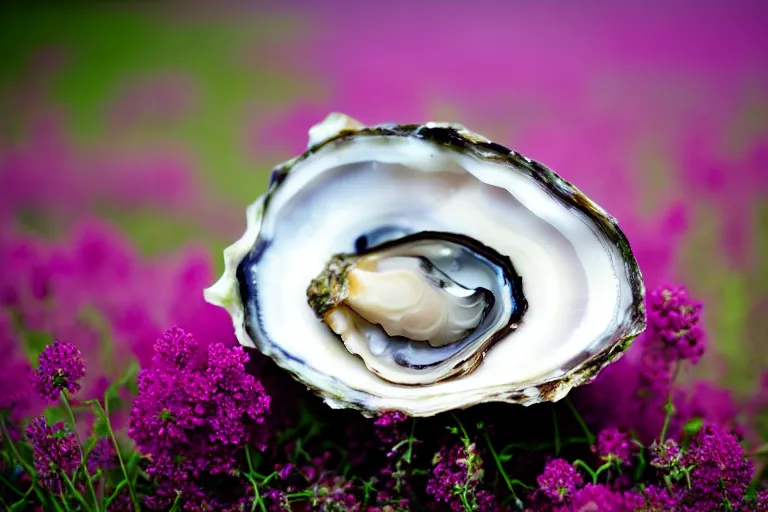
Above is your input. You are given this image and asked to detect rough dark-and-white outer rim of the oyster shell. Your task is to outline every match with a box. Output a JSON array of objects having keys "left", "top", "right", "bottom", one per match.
[{"left": 204, "top": 113, "right": 646, "bottom": 417}]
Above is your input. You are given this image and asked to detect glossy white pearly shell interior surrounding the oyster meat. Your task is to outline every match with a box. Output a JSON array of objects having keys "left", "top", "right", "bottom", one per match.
[{"left": 206, "top": 121, "right": 632, "bottom": 416}]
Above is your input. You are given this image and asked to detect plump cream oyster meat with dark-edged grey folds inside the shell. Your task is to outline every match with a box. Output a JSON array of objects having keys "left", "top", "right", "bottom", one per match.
[{"left": 307, "top": 231, "right": 526, "bottom": 384}]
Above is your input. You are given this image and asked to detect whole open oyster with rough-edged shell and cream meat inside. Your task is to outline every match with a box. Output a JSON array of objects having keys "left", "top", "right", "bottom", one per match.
[{"left": 205, "top": 114, "right": 645, "bottom": 416}]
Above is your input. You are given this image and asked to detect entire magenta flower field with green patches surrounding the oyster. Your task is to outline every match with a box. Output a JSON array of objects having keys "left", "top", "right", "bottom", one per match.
[{"left": 0, "top": 1, "right": 768, "bottom": 512}]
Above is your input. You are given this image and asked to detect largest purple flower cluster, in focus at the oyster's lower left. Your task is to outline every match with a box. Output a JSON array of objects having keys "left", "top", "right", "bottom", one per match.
[{"left": 128, "top": 328, "right": 270, "bottom": 509}]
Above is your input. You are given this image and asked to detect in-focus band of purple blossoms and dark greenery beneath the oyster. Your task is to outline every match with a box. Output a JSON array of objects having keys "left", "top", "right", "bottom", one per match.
[{"left": 0, "top": 287, "right": 768, "bottom": 512}]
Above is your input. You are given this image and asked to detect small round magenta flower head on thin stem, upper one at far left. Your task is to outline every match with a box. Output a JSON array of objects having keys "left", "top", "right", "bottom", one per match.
[{"left": 32, "top": 341, "right": 85, "bottom": 402}]
